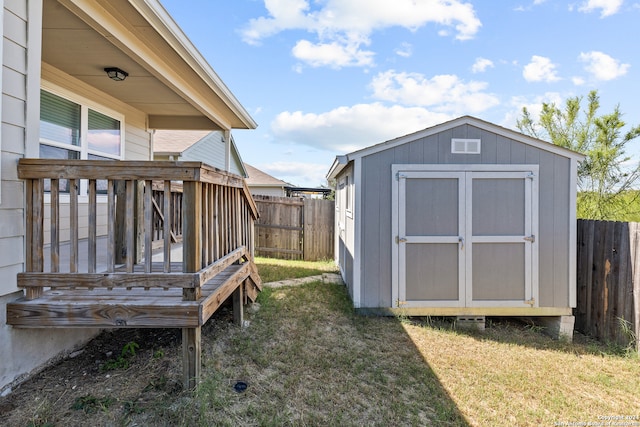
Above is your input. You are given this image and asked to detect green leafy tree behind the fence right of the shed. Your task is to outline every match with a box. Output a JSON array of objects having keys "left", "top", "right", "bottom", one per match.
[{"left": 517, "top": 90, "right": 640, "bottom": 221}]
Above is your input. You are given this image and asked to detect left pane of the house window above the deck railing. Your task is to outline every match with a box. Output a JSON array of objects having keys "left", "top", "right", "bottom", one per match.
[{"left": 40, "top": 90, "right": 80, "bottom": 146}]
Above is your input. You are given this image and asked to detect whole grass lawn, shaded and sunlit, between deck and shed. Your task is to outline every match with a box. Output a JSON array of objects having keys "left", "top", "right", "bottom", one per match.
[{"left": 6, "top": 260, "right": 640, "bottom": 426}]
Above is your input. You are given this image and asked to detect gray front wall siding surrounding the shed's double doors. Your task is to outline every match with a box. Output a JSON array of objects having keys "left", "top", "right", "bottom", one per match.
[{"left": 359, "top": 124, "right": 571, "bottom": 308}]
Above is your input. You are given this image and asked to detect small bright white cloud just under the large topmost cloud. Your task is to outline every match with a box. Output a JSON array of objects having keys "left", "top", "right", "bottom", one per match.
[{"left": 292, "top": 40, "right": 374, "bottom": 68}]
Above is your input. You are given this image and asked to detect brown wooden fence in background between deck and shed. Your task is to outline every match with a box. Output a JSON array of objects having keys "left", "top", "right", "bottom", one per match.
[{"left": 253, "top": 196, "right": 335, "bottom": 261}]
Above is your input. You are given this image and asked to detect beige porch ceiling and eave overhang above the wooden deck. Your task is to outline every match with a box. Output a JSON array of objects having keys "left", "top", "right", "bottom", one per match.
[{"left": 42, "top": 0, "right": 256, "bottom": 130}]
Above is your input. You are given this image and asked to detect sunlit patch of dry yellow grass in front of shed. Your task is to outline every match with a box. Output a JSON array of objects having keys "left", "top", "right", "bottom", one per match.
[{"left": 404, "top": 320, "right": 640, "bottom": 426}]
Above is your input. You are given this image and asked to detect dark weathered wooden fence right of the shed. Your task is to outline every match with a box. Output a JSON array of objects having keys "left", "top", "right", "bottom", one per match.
[{"left": 576, "top": 220, "right": 640, "bottom": 351}]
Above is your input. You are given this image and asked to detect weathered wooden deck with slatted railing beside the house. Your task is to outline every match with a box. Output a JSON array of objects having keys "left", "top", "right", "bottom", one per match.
[{"left": 7, "top": 159, "right": 260, "bottom": 386}]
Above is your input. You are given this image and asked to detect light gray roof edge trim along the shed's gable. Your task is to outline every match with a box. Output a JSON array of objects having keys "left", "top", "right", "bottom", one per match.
[{"left": 327, "top": 116, "right": 585, "bottom": 179}]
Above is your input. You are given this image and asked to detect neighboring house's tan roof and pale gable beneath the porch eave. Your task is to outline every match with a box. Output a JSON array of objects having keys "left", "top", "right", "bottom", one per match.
[{"left": 153, "top": 130, "right": 247, "bottom": 177}]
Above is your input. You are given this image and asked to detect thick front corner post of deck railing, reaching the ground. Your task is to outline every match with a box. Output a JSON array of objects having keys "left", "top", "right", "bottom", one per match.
[{"left": 182, "top": 181, "right": 202, "bottom": 390}]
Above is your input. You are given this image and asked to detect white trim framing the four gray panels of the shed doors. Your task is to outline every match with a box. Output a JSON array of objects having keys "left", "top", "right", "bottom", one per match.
[{"left": 391, "top": 164, "right": 539, "bottom": 308}]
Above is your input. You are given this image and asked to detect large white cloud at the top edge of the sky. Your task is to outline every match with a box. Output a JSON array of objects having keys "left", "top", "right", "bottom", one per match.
[{"left": 241, "top": 0, "right": 482, "bottom": 68}]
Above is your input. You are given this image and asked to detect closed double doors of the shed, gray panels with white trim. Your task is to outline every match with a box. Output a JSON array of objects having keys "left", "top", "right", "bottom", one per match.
[{"left": 394, "top": 167, "right": 538, "bottom": 307}]
